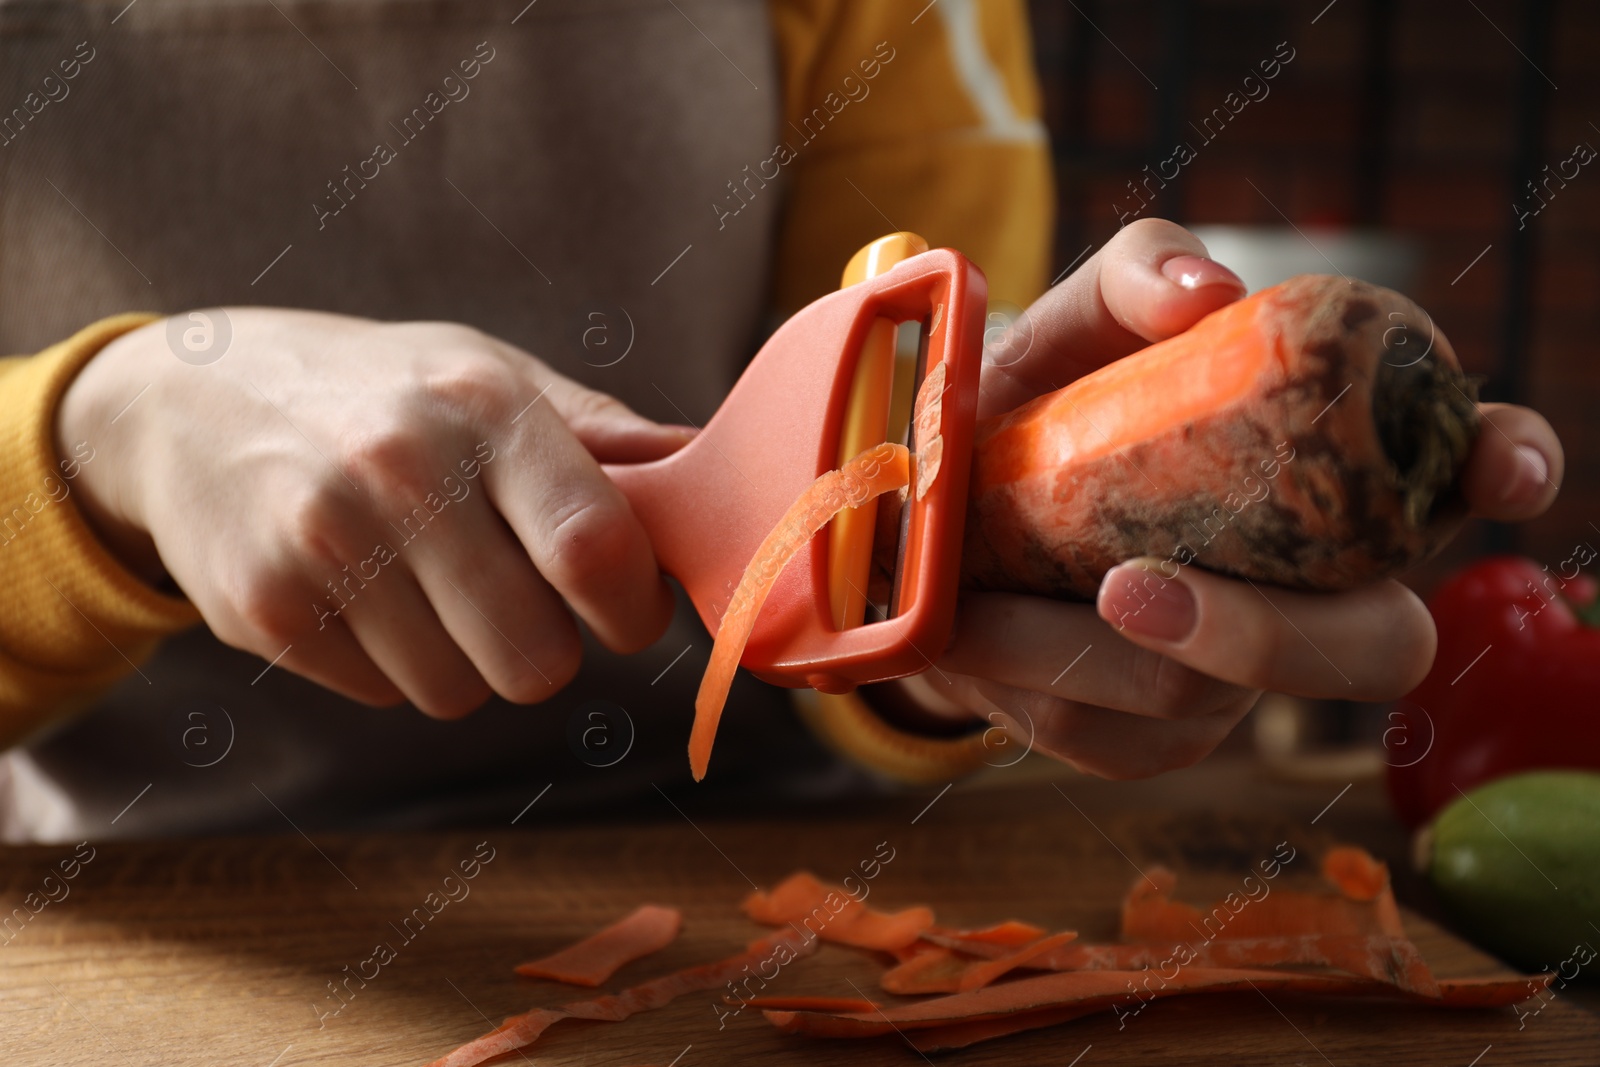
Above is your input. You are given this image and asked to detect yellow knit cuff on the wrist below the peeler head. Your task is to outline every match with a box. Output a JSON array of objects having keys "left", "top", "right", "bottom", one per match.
[{"left": 792, "top": 689, "right": 989, "bottom": 785}]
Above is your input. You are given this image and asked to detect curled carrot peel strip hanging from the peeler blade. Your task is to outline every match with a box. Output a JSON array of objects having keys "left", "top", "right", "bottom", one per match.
[{"left": 690, "top": 438, "right": 915, "bottom": 782}]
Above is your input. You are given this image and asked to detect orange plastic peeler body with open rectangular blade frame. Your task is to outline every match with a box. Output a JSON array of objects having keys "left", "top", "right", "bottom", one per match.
[{"left": 605, "top": 248, "right": 989, "bottom": 693}]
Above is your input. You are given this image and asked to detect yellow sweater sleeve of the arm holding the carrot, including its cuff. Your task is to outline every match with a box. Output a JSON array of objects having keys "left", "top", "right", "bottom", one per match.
[{"left": 766, "top": 0, "right": 1054, "bottom": 784}]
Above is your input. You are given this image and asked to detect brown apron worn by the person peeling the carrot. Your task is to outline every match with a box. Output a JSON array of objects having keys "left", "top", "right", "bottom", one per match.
[{"left": 0, "top": 0, "right": 862, "bottom": 838}]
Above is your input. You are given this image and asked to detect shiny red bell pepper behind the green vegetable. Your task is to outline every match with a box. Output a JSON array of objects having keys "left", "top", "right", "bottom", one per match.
[{"left": 1384, "top": 556, "right": 1600, "bottom": 825}]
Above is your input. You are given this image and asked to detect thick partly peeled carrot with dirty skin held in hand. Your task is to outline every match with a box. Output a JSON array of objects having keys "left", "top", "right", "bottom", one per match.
[{"left": 962, "top": 275, "right": 1478, "bottom": 600}]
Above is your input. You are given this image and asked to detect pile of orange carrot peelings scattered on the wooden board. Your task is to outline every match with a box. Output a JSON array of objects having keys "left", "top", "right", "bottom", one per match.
[{"left": 430, "top": 846, "right": 1554, "bottom": 1067}]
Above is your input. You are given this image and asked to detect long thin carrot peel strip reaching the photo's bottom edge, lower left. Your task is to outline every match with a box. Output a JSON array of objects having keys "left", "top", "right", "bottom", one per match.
[{"left": 429, "top": 933, "right": 816, "bottom": 1067}]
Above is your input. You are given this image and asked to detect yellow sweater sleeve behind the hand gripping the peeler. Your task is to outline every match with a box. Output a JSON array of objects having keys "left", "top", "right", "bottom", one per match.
[{"left": 0, "top": 315, "right": 200, "bottom": 747}]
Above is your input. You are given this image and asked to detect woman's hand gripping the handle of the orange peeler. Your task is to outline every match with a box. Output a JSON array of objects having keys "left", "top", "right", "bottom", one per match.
[{"left": 58, "top": 309, "right": 686, "bottom": 718}]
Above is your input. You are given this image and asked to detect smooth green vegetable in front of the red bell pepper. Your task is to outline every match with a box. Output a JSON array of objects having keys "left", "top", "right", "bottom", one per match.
[{"left": 1418, "top": 771, "right": 1600, "bottom": 982}]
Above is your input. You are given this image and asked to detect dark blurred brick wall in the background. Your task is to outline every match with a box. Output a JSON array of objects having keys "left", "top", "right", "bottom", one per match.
[{"left": 1030, "top": 0, "right": 1600, "bottom": 587}]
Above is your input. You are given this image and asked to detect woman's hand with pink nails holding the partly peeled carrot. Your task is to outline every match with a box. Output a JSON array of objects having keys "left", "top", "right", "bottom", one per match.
[{"left": 909, "top": 219, "right": 1563, "bottom": 777}]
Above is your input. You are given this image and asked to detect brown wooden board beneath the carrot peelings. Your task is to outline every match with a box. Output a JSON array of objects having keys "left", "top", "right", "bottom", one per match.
[{"left": 0, "top": 777, "right": 1600, "bottom": 1067}]
